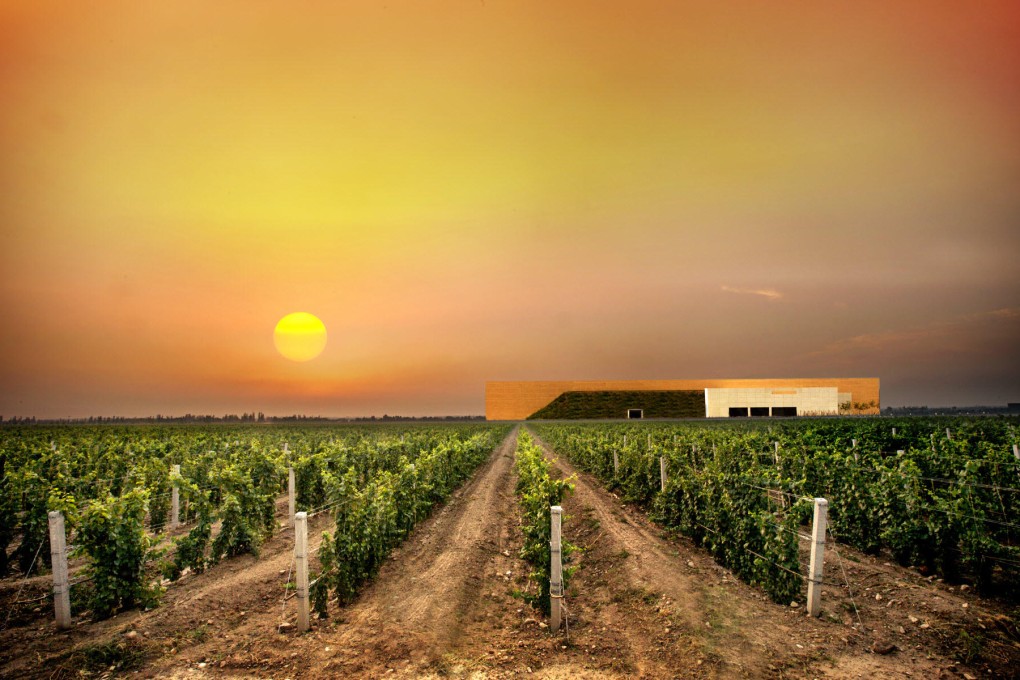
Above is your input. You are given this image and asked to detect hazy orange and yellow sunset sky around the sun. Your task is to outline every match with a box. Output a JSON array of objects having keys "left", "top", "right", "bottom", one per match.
[{"left": 0, "top": 0, "right": 1020, "bottom": 418}]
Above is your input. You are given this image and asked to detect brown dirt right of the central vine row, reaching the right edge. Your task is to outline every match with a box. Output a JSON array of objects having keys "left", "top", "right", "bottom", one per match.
[{"left": 536, "top": 428, "right": 1020, "bottom": 678}]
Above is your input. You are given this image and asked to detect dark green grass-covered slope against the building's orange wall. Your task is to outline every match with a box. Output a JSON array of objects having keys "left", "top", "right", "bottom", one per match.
[{"left": 527, "top": 390, "right": 705, "bottom": 420}]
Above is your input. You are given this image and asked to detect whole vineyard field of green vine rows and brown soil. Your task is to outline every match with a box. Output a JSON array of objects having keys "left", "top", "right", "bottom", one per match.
[{"left": 0, "top": 419, "right": 1020, "bottom": 678}]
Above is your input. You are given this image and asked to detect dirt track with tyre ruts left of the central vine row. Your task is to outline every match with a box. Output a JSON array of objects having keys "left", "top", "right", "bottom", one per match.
[{"left": 273, "top": 428, "right": 517, "bottom": 677}]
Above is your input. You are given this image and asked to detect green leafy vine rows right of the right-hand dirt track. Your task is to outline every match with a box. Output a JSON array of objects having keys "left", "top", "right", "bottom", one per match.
[{"left": 536, "top": 420, "right": 1020, "bottom": 603}]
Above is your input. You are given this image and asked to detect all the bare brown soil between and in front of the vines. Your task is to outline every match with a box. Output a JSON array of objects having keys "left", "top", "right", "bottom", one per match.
[{"left": 0, "top": 431, "right": 1020, "bottom": 679}]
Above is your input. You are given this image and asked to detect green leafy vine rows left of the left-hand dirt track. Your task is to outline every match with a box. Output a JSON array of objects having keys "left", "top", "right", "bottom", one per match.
[{"left": 0, "top": 425, "right": 506, "bottom": 623}]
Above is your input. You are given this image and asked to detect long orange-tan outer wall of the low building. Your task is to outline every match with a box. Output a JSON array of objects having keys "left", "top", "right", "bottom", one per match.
[{"left": 486, "top": 378, "right": 881, "bottom": 420}]
